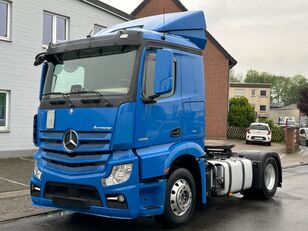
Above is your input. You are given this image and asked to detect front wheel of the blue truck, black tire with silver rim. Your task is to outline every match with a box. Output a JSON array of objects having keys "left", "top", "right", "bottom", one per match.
[{"left": 155, "top": 168, "right": 196, "bottom": 228}]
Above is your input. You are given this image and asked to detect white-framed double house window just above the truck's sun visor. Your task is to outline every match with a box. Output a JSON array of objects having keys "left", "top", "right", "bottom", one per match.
[{"left": 43, "top": 12, "right": 69, "bottom": 45}]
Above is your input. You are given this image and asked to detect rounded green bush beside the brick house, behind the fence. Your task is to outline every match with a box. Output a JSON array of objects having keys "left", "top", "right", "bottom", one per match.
[{"left": 228, "top": 97, "right": 257, "bottom": 128}]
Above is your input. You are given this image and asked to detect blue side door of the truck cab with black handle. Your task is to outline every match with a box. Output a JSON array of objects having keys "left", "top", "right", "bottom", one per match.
[{"left": 135, "top": 50, "right": 182, "bottom": 148}]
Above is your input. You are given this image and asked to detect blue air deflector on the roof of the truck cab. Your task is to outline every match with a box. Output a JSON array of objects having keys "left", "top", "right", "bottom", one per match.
[{"left": 96, "top": 11, "right": 206, "bottom": 50}]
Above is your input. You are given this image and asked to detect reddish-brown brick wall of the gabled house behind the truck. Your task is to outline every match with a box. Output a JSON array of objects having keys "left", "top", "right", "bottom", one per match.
[{"left": 134, "top": 0, "right": 229, "bottom": 139}]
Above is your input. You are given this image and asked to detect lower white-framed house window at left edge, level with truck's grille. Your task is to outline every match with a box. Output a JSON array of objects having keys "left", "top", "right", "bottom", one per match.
[{"left": 0, "top": 90, "right": 10, "bottom": 132}]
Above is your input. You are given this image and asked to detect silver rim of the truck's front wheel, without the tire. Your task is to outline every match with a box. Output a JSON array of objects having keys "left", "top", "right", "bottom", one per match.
[{"left": 170, "top": 179, "right": 192, "bottom": 216}]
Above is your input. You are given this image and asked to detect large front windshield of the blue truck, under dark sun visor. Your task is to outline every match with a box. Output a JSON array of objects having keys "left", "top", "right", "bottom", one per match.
[{"left": 43, "top": 49, "right": 136, "bottom": 95}]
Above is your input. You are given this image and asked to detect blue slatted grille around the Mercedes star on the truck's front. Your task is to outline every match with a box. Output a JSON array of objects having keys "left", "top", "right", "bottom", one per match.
[{"left": 39, "top": 130, "right": 112, "bottom": 175}]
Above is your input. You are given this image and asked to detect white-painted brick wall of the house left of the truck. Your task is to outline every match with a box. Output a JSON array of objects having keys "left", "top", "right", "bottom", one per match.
[{"left": 0, "top": 0, "right": 124, "bottom": 157}]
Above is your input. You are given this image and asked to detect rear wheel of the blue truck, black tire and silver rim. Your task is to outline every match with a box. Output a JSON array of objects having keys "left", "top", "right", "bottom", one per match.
[{"left": 260, "top": 157, "right": 279, "bottom": 199}]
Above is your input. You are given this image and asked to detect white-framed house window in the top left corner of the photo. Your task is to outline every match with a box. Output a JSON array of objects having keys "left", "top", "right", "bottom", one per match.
[{"left": 0, "top": 0, "right": 11, "bottom": 40}]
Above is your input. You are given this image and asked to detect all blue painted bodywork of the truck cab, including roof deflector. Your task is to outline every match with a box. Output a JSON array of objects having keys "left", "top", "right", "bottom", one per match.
[{"left": 31, "top": 11, "right": 206, "bottom": 219}]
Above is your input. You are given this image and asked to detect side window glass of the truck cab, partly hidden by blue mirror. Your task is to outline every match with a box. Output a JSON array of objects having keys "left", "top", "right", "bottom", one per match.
[{"left": 142, "top": 53, "right": 176, "bottom": 99}]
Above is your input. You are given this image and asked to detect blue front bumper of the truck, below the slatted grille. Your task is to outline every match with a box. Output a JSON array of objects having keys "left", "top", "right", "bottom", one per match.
[{"left": 30, "top": 149, "right": 166, "bottom": 219}]
